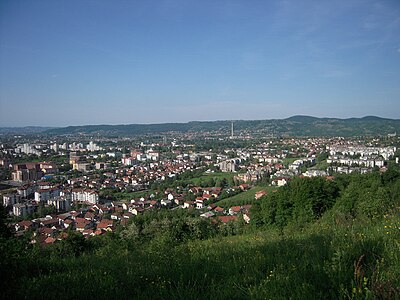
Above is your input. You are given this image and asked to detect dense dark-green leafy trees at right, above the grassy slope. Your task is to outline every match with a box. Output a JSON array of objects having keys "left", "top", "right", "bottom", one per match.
[{"left": 252, "top": 168, "right": 400, "bottom": 229}]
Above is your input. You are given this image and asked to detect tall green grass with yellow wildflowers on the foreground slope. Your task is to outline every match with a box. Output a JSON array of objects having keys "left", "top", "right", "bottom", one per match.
[{"left": 8, "top": 211, "right": 400, "bottom": 299}]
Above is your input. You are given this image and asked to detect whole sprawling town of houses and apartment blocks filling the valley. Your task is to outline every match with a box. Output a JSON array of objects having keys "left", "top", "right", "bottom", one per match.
[{"left": 0, "top": 133, "right": 398, "bottom": 244}]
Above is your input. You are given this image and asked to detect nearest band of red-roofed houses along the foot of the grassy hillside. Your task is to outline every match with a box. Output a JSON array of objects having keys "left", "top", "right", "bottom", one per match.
[{"left": 10, "top": 184, "right": 267, "bottom": 245}]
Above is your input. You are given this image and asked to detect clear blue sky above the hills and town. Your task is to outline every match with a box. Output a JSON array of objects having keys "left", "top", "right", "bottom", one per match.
[{"left": 0, "top": 0, "right": 400, "bottom": 126}]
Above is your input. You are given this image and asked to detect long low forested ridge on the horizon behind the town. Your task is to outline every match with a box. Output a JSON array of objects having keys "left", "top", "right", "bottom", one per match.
[{"left": 46, "top": 116, "right": 400, "bottom": 136}]
